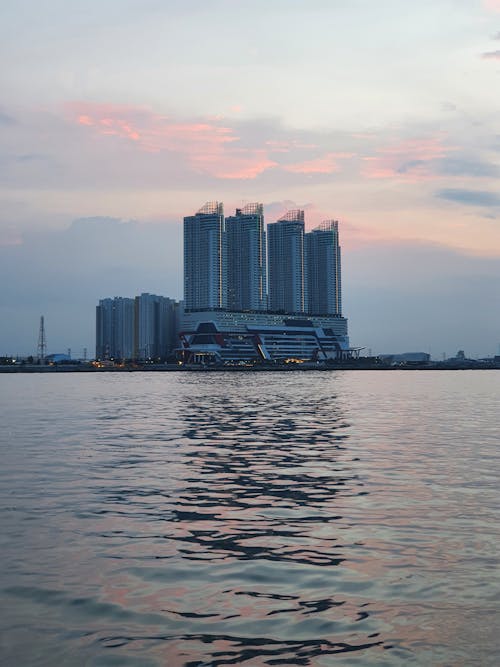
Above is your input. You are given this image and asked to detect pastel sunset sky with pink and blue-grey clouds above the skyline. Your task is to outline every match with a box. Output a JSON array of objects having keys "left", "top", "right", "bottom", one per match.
[{"left": 0, "top": 0, "right": 500, "bottom": 358}]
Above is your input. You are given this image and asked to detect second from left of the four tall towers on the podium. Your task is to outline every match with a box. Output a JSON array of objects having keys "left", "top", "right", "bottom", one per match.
[{"left": 226, "top": 204, "right": 267, "bottom": 310}]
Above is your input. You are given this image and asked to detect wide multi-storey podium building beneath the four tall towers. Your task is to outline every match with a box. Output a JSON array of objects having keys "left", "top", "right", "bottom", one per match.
[{"left": 180, "top": 311, "right": 353, "bottom": 363}]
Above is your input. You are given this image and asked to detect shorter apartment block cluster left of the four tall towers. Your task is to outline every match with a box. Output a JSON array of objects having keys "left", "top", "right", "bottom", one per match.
[{"left": 96, "top": 294, "right": 180, "bottom": 359}]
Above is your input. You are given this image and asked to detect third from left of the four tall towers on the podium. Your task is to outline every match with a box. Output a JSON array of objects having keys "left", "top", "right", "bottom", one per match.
[{"left": 267, "top": 210, "right": 307, "bottom": 313}]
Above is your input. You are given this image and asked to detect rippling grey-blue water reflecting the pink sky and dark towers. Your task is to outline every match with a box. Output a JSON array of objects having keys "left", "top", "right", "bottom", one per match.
[{"left": 0, "top": 371, "right": 500, "bottom": 667}]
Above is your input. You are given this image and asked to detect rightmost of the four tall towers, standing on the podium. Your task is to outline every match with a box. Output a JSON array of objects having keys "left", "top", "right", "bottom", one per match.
[{"left": 305, "top": 220, "right": 342, "bottom": 315}]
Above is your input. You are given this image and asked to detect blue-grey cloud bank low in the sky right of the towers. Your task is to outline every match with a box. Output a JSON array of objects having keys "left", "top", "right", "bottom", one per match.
[{"left": 342, "top": 240, "right": 500, "bottom": 358}]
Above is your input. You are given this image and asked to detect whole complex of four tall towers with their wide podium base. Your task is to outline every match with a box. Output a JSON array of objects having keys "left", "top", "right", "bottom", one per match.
[{"left": 177, "top": 202, "right": 352, "bottom": 364}]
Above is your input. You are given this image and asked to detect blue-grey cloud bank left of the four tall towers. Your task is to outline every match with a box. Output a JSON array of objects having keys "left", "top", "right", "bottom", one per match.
[{"left": 0, "top": 217, "right": 182, "bottom": 355}]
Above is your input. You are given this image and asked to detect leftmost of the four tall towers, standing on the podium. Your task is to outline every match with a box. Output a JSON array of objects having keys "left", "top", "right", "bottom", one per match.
[{"left": 184, "top": 202, "right": 227, "bottom": 310}]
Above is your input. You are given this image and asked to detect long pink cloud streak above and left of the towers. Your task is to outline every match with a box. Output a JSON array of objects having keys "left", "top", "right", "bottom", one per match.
[{"left": 66, "top": 102, "right": 276, "bottom": 179}]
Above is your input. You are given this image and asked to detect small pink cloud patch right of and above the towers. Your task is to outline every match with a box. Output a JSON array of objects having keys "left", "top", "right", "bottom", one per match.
[{"left": 362, "top": 137, "right": 454, "bottom": 183}]
